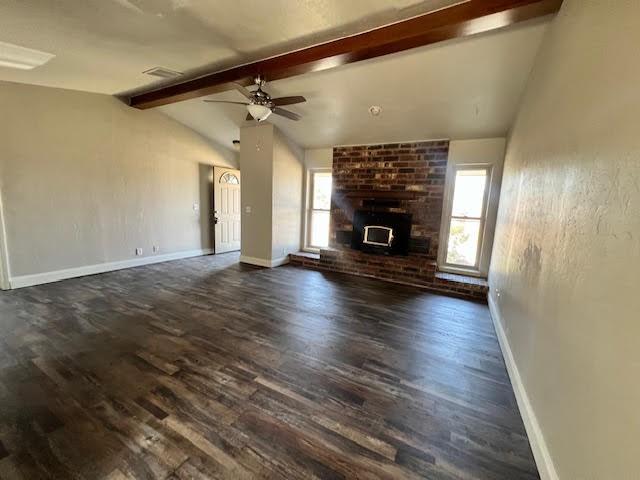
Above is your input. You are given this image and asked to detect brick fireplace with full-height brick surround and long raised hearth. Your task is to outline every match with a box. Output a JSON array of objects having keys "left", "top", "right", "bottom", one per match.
[{"left": 294, "top": 140, "right": 486, "bottom": 300}]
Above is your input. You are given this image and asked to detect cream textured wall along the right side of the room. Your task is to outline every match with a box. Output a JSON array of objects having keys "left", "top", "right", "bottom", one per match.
[{"left": 490, "top": 0, "right": 640, "bottom": 480}]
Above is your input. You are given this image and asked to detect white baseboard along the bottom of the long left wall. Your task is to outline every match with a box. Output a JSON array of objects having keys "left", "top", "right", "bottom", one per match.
[{"left": 10, "top": 248, "right": 213, "bottom": 288}]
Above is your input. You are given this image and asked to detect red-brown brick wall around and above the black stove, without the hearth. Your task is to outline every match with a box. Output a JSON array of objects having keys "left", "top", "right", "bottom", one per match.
[{"left": 330, "top": 140, "right": 449, "bottom": 260}]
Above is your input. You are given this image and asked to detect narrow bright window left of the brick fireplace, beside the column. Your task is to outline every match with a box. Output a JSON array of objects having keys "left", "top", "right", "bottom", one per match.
[{"left": 306, "top": 170, "right": 332, "bottom": 250}]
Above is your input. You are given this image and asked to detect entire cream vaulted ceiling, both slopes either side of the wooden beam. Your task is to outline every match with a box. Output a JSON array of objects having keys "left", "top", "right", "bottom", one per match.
[{"left": 0, "top": 0, "right": 549, "bottom": 147}]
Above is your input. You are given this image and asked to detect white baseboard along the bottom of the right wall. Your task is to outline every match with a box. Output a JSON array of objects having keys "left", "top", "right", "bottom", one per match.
[{"left": 488, "top": 292, "right": 559, "bottom": 480}]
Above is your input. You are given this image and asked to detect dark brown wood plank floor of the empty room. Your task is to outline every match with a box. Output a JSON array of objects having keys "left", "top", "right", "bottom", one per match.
[{"left": 0, "top": 254, "right": 538, "bottom": 480}]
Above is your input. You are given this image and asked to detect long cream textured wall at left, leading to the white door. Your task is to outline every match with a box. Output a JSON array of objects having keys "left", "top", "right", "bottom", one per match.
[{"left": 0, "top": 83, "right": 237, "bottom": 277}]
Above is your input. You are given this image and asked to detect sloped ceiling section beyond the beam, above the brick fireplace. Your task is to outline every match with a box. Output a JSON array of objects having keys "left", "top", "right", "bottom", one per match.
[{"left": 160, "top": 19, "right": 548, "bottom": 148}]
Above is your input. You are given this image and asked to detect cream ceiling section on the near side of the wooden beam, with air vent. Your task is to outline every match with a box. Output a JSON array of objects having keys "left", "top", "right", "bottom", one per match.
[{"left": 0, "top": 0, "right": 460, "bottom": 94}]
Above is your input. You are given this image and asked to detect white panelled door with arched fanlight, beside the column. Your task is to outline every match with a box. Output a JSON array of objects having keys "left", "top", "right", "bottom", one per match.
[{"left": 213, "top": 167, "right": 240, "bottom": 253}]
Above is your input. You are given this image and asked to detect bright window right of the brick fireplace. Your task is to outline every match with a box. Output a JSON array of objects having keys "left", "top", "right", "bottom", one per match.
[{"left": 442, "top": 165, "right": 491, "bottom": 273}]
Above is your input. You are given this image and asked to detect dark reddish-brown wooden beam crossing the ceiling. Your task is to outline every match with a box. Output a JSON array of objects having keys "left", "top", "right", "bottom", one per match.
[{"left": 129, "top": 0, "right": 562, "bottom": 109}]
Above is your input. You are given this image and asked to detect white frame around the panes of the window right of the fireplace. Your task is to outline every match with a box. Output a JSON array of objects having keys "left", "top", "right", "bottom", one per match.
[{"left": 438, "top": 163, "right": 496, "bottom": 277}]
